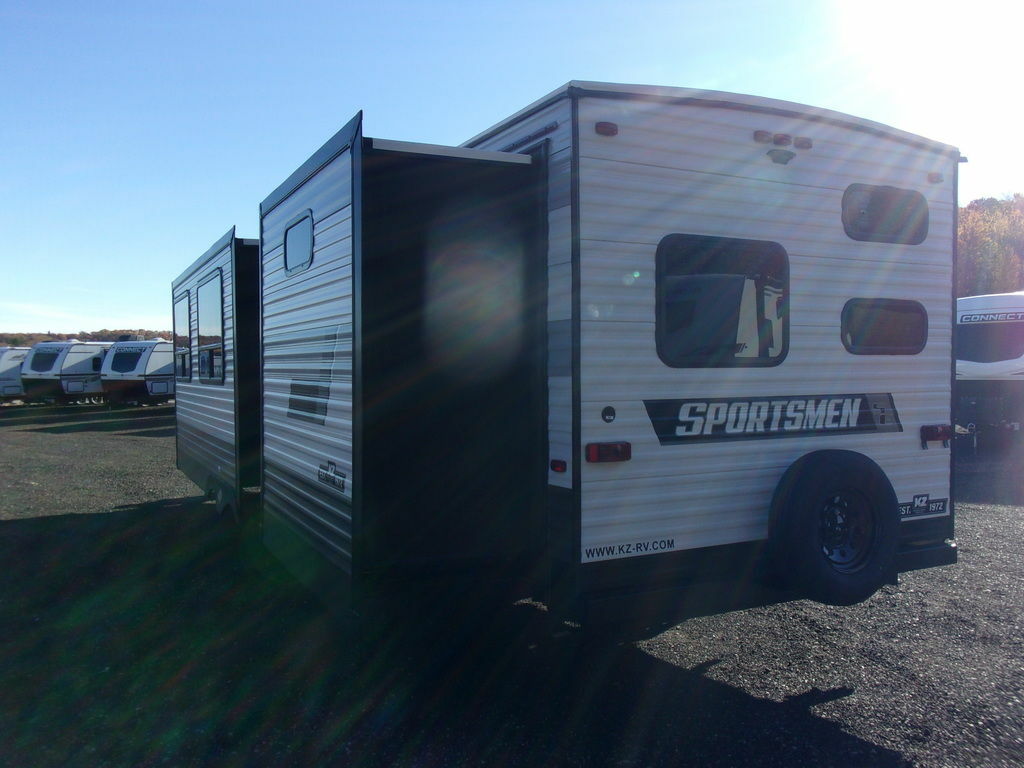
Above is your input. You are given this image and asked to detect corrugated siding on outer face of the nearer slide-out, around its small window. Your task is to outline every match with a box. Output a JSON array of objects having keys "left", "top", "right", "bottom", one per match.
[{"left": 261, "top": 152, "right": 353, "bottom": 571}]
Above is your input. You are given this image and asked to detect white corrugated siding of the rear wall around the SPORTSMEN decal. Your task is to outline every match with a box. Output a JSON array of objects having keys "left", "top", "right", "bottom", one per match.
[{"left": 580, "top": 98, "right": 955, "bottom": 559}]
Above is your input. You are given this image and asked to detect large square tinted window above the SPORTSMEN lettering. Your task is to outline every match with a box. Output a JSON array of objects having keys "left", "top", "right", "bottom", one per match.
[{"left": 655, "top": 234, "right": 790, "bottom": 368}]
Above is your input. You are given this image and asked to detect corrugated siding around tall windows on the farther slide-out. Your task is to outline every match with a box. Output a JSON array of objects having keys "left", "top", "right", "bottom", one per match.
[{"left": 174, "top": 244, "right": 239, "bottom": 499}]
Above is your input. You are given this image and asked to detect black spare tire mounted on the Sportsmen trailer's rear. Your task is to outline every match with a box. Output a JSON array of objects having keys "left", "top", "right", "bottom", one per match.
[{"left": 769, "top": 451, "right": 899, "bottom": 605}]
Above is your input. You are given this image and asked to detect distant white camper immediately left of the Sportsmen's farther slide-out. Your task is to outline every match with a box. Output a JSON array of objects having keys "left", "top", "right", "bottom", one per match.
[{"left": 100, "top": 339, "right": 174, "bottom": 403}]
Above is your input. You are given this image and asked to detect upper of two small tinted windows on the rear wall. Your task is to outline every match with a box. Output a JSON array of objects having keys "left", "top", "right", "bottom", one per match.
[{"left": 843, "top": 184, "right": 928, "bottom": 246}]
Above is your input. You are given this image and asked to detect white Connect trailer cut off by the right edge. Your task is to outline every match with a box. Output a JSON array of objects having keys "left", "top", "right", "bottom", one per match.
[{"left": 954, "top": 291, "right": 1024, "bottom": 452}]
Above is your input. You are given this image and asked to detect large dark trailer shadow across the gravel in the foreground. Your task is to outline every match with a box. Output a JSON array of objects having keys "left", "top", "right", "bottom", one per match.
[{"left": 0, "top": 497, "right": 907, "bottom": 766}]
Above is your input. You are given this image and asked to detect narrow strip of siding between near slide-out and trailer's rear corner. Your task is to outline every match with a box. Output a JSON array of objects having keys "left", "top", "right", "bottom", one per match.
[{"left": 475, "top": 99, "right": 572, "bottom": 487}]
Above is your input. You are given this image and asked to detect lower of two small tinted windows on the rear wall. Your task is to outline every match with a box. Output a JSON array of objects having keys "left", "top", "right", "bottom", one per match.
[{"left": 842, "top": 299, "right": 928, "bottom": 354}]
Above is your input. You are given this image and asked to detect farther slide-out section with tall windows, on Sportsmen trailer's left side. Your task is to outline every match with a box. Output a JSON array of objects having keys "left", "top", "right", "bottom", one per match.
[{"left": 171, "top": 228, "right": 259, "bottom": 513}]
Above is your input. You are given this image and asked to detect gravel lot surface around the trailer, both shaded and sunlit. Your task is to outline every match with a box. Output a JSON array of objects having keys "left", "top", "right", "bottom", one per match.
[{"left": 0, "top": 408, "right": 1024, "bottom": 767}]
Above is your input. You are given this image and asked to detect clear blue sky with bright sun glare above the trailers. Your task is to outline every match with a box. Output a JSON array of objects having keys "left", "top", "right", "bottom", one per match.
[{"left": 0, "top": 0, "right": 1024, "bottom": 333}]
